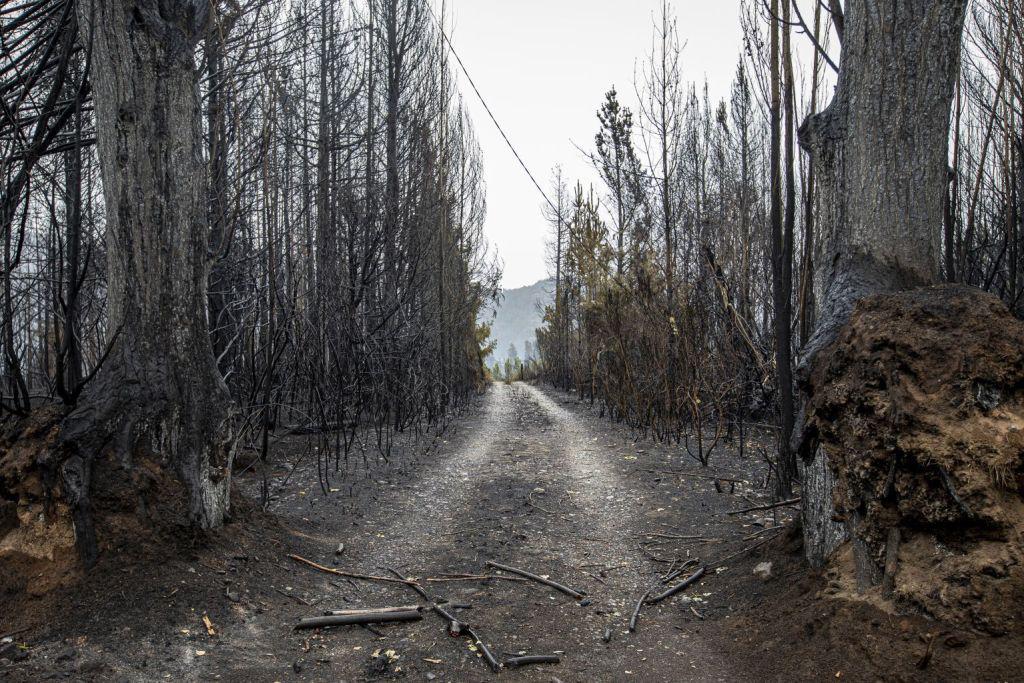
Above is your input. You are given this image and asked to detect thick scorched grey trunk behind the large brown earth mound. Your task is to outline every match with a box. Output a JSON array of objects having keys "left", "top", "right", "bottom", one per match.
[{"left": 796, "top": 0, "right": 965, "bottom": 564}]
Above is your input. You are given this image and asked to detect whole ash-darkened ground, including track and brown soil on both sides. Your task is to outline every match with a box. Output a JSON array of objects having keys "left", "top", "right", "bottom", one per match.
[{"left": 0, "top": 384, "right": 1022, "bottom": 683}]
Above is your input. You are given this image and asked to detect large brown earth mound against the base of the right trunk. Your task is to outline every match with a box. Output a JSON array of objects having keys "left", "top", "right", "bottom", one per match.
[{"left": 808, "top": 286, "right": 1024, "bottom": 633}]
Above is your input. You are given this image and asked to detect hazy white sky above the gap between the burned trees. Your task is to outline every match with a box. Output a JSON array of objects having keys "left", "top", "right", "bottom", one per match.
[{"left": 444, "top": 0, "right": 742, "bottom": 288}]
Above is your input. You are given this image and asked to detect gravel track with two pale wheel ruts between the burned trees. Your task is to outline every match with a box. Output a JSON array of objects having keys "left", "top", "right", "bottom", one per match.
[{"left": 222, "top": 384, "right": 753, "bottom": 681}]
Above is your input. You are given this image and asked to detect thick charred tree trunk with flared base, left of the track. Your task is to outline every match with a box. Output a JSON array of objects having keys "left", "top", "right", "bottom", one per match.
[{"left": 59, "top": 0, "right": 233, "bottom": 565}]
